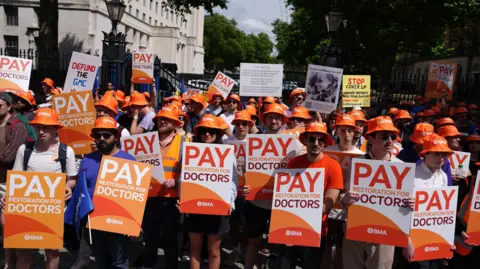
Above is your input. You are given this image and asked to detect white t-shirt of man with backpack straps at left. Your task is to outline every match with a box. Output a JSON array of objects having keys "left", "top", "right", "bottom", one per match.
[{"left": 13, "top": 143, "right": 78, "bottom": 177}]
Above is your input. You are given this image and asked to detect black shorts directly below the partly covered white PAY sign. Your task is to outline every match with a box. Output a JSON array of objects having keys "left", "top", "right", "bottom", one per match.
[{"left": 245, "top": 201, "right": 272, "bottom": 238}]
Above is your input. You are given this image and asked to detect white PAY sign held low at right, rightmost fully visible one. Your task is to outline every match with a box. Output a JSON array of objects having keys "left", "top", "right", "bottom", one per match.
[{"left": 410, "top": 186, "right": 458, "bottom": 261}]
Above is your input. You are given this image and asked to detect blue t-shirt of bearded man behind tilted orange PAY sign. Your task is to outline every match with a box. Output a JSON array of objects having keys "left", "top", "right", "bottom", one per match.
[{"left": 78, "top": 150, "right": 136, "bottom": 197}]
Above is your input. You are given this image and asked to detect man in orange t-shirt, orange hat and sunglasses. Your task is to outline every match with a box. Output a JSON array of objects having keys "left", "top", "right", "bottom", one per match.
[{"left": 277, "top": 122, "right": 342, "bottom": 269}]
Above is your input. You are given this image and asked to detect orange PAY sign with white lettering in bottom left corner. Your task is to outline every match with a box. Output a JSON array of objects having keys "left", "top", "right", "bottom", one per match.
[{"left": 3, "top": 170, "right": 66, "bottom": 249}]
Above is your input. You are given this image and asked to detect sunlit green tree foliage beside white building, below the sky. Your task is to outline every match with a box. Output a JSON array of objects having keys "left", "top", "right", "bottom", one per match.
[{"left": 203, "top": 14, "right": 273, "bottom": 70}]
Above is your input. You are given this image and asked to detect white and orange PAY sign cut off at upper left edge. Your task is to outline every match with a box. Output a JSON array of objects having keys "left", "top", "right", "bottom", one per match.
[{"left": 0, "top": 56, "right": 32, "bottom": 93}]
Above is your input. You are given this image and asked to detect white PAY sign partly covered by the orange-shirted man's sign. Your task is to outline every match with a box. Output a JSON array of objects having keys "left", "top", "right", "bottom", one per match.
[{"left": 245, "top": 134, "right": 300, "bottom": 200}]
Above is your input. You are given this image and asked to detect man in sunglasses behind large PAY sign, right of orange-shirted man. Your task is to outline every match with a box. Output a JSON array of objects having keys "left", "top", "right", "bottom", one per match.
[{"left": 341, "top": 116, "right": 402, "bottom": 269}]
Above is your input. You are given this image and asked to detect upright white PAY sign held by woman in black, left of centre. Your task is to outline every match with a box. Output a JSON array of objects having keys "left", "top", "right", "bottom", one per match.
[{"left": 180, "top": 143, "right": 235, "bottom": 216}]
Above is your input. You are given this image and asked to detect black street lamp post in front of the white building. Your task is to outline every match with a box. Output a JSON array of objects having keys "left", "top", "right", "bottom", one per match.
[{"left": 101, "top": 0, "right": 126, "bottom": 92}]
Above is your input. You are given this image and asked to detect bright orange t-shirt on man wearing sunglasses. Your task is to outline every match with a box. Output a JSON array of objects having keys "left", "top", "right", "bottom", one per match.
[{"left": 287, "top": 154, "right": 343, "bottom": 237}]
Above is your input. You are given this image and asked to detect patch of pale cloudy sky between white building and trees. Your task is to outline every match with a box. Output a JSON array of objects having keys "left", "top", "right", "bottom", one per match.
[{"left": 214, "top": 0, "right": 290, "bottom": 41}]
